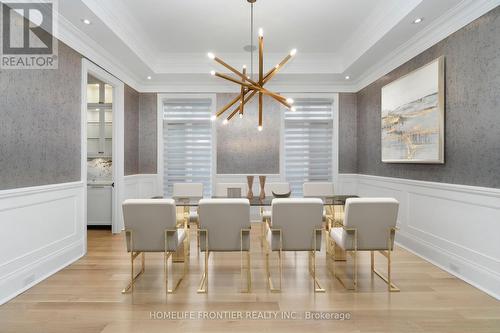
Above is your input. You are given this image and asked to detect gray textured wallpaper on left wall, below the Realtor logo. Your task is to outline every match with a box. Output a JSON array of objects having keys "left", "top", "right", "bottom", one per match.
[{"left": 0, "top": 42, "right": 81, "bottom": 190}]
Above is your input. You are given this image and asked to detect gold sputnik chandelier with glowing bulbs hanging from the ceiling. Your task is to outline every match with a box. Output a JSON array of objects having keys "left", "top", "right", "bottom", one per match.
[{"left": 208, "top": 0, "right": 297, "bottom": 131}]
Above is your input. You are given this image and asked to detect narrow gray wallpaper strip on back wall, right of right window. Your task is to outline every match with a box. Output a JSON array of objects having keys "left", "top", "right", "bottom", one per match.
[{"left": 339, "top": 93, "right": 358, "bottom": 173}]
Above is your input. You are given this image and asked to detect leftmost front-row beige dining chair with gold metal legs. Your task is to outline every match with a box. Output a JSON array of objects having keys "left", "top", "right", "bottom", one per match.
[{"left": 122, "top": 199, "right": 189, "bottom": 293}]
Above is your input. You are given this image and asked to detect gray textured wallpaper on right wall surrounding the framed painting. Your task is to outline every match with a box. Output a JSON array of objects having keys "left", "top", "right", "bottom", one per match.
[{"left": 357, "top": 7, "right": 500, "bottom": 188}]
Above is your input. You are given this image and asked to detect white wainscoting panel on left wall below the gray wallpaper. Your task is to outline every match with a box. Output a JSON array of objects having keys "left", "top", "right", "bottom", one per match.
[{"left": 0, "top": 182, "right": 86, "bottom": 304}]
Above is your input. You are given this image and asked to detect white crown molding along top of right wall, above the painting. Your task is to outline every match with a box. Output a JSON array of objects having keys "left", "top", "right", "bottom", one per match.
[{"left": 354, "top": 0, "right": 500, "bottom": 91}]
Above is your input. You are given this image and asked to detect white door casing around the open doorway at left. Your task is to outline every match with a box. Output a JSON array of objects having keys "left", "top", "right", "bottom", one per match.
[{"left": 81, "top": 59, "right": 125, "bottom": 233}]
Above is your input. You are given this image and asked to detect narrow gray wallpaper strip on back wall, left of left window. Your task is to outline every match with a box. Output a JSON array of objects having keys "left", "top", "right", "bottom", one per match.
[{"left": 139, "top": 93, "right": 158, "bottom": 174}]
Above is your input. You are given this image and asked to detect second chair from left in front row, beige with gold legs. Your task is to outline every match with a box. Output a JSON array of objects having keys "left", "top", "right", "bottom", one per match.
[{"left": 198, "top": 198, "right": 252, "bottom": 293}]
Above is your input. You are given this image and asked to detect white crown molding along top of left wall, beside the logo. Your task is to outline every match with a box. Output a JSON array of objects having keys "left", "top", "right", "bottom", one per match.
[{"left": 55, "top": 12, "right": 140, "bottom": 90}]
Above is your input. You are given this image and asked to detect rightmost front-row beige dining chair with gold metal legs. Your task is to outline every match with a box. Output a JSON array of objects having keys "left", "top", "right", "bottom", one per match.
[{"left": 330, "top": 198, "right": 399, "bottom": 291}]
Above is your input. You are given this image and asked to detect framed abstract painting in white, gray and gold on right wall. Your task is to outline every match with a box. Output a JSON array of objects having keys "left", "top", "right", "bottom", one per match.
[{"left": 381, "top": 57, "right": 445, "bottom": 164}]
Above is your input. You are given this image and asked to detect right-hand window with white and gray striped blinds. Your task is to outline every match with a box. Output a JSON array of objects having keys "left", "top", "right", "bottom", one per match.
[{"left": 284, "top": 98, "right": 333, "bottom": 196}]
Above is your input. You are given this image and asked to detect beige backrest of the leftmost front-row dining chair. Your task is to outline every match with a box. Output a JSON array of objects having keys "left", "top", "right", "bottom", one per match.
[{"left": 122, "top": 199, "right": 176, "bottom": 252}]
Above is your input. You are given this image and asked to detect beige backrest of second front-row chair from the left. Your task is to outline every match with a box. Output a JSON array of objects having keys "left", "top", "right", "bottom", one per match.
[{"left": 199, "top": 198, "right": 250, "bottom": 251}]
